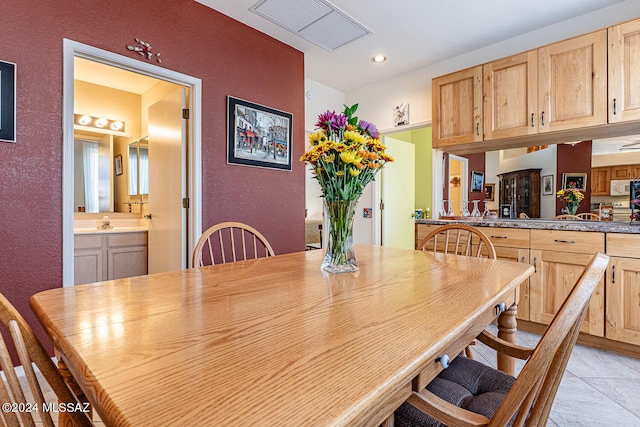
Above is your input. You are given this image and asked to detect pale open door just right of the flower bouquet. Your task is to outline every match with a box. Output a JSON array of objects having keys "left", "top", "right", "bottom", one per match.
[{"left": 380, "top": 137, "right": 416, "bottom": 249}]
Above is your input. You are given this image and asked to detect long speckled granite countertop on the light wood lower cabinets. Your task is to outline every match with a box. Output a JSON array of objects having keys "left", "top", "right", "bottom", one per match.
[{"left": 416, "top": 218, "right": 640, "bottom": 234}]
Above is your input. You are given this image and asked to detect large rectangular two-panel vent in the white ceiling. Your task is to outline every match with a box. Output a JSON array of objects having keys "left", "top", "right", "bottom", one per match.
[{"left": 249, "top": 0, "right": 371, "bottom": 51}]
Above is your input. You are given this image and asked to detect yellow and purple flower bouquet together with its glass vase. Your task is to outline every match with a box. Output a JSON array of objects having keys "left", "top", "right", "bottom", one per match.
[{"left": 300, "top": 104, "right": 393, "bottom": 273}]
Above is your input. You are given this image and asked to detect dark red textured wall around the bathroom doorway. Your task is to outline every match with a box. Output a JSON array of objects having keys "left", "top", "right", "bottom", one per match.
[{"left": 0, "top": 0, "right": 305, "bottom": 352}]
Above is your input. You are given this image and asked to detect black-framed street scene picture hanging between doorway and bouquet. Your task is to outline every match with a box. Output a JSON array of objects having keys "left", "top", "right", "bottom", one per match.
[{"left": 227, "top": 96, "right": 292, "bottom": 171}]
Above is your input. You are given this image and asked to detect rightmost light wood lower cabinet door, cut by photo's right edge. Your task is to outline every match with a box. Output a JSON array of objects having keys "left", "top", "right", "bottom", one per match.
[{"left": 605, "top": 257, "right": 640, "bottom": 345}]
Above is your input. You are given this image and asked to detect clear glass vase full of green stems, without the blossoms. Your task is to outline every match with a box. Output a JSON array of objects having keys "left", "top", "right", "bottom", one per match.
[{"left": 321, "top": 200, "right": 359, "bottom": 273}]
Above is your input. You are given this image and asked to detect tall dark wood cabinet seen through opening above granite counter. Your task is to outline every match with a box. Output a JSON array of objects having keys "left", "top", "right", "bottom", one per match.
[{"left": 498, "top": 169, "right": 542, "bottom": 218}]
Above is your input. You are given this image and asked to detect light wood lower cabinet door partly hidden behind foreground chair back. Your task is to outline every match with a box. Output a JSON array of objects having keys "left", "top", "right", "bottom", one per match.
[{"left": 529, "top": 249, "right": 604, "bottom": 337}]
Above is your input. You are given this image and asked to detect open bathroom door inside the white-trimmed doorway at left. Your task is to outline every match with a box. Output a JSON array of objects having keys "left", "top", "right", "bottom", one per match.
[{"left": 148, "top": 89, "right": 188, "bottom": 274}]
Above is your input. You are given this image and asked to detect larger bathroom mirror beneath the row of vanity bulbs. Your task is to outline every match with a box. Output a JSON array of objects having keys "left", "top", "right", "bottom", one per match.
[{"left": 74, "top": 133, "right": 113, "bottom": 213}]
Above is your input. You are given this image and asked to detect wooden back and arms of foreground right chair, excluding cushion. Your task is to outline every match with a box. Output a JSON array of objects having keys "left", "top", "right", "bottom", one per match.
[{"left": 408, "top": 253, "right": 609, "bottom": 427}]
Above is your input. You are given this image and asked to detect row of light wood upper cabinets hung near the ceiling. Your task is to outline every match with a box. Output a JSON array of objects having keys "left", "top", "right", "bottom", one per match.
[{"left": 432, "top": 19, "right": 640, "bottom": 153}]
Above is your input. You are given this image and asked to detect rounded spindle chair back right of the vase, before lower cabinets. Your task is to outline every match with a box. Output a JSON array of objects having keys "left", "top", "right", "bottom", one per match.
[{"left": 417, "top": 224, "right": 496, "bottom": 259}]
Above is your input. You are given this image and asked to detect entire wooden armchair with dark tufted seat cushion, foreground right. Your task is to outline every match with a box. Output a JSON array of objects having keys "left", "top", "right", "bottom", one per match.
[{"left": 387, "top": 253, "right": 609, "bottom": 427}]
